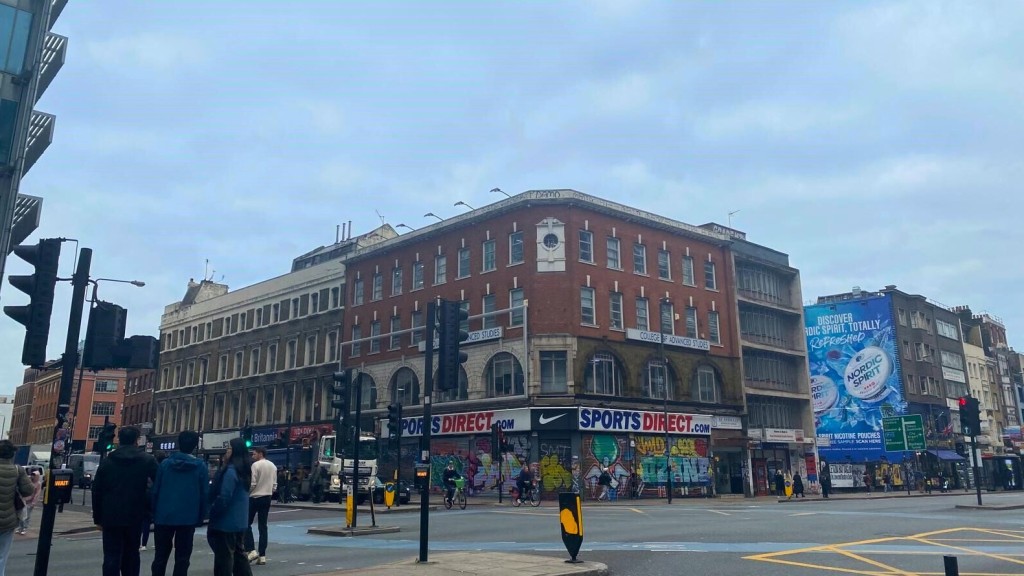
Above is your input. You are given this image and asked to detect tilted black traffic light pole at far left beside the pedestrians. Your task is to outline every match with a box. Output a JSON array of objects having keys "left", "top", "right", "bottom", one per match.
[{"left": 33, "top": 243, "right": 92, "bottom": 576}]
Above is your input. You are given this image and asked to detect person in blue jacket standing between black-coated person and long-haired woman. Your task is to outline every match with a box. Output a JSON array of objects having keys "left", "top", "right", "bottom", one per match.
[{"left": 152, "top": 430, "right": 210, "bottom": 576}]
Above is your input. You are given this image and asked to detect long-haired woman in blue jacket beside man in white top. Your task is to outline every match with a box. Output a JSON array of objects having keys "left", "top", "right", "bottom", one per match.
[{"left": 206, "top": 438, "right": 252, "bottom": 576}]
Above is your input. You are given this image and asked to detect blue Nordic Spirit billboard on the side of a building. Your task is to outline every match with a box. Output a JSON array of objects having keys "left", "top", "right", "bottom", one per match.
[{"left": 804, "top": 296, "right": 906, "bottom": 463}]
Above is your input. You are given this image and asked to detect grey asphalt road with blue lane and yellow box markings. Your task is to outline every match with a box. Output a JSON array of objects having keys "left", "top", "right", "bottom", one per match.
[{"left": 8, "top": 493, "right": 1024, "bottom": 576}]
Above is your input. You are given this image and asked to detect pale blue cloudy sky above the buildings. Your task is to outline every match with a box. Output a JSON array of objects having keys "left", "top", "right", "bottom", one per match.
[{"left": 0, "top": 0, "right": 1024, "bottom": 394}]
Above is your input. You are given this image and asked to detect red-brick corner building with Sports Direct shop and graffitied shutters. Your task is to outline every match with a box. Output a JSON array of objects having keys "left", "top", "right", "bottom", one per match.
[{"left": 342, "top": 190, "right": 765, "bottom": 497}]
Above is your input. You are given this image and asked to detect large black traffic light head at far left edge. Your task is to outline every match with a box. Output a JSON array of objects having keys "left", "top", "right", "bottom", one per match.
[{"left": 3, "top": 238, "right": 60, "bottom": 368}]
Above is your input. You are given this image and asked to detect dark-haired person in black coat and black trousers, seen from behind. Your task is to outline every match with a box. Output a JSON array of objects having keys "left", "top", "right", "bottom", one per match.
[{"left": 92, "top": 426, "right": 157, "bottom": 576}]
